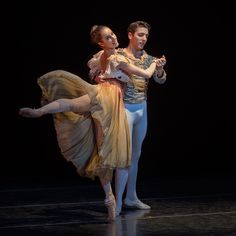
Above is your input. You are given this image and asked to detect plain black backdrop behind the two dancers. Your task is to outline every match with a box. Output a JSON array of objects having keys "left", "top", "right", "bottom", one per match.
[{"left": 4, "top": 1, "right": 236, "bottom": 186}]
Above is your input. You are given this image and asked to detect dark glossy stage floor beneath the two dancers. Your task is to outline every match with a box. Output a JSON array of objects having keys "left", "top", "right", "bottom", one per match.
[{"left": 0, "top": 177, "right": 236, "bottom": 236}]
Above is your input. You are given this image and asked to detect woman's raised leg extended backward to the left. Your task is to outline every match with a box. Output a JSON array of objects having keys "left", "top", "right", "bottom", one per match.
[{"left": 19, "top": 95, "right": 91, "bottom": 118}]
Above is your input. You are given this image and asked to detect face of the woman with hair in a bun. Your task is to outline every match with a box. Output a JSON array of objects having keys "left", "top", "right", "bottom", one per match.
[{"left": 99, "top": 27, "right": 119, "bottom": 49}]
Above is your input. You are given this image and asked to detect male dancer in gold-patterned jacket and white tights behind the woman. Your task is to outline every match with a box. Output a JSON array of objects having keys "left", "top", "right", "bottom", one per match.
[{"left": 115, "top": 21, "right": 166, "bottom": 215}]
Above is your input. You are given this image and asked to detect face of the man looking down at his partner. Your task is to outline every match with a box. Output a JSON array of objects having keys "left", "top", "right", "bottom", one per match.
[{"left": 128, "top": 27, "right": 149, "bottom": 51}]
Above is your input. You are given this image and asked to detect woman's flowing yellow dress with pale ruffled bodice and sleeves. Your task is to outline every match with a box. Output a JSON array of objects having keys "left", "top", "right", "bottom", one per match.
[{"left": 38, "top": 52, "right": 131, "bottom": 180}]
